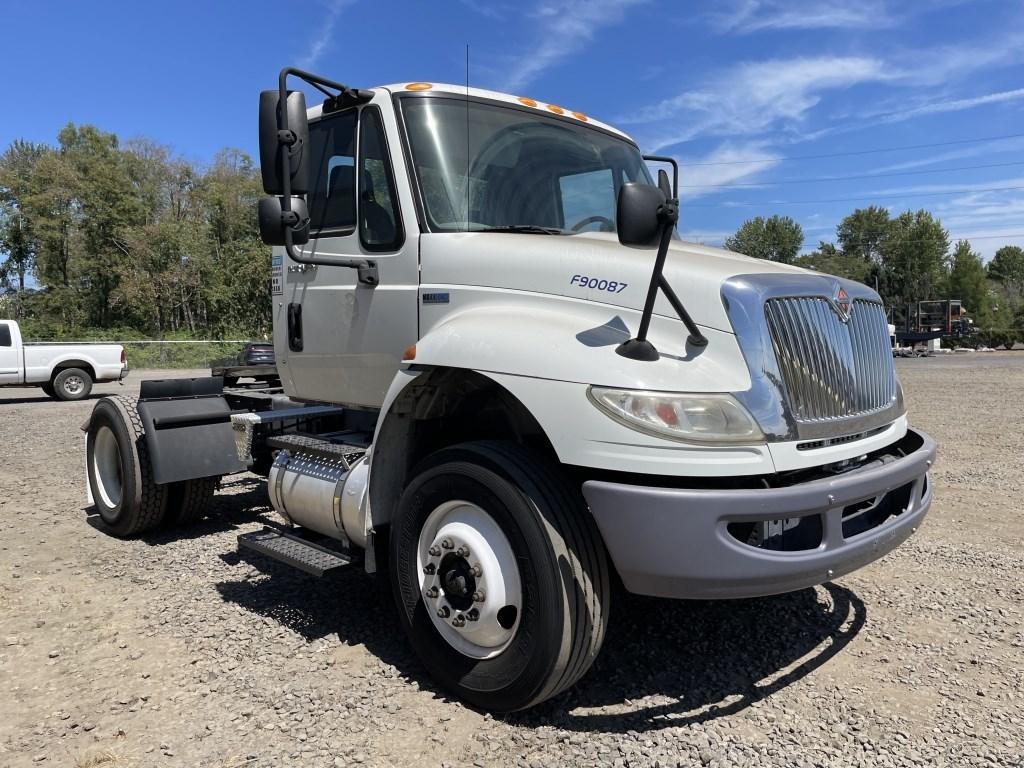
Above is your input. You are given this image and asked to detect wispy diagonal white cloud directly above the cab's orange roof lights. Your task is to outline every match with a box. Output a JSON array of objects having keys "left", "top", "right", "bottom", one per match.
[{"left": 499, "top": 0, "right": 647, "bottom": 92}]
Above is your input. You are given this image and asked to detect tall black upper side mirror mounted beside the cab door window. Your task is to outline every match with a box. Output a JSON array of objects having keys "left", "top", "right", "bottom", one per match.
[{"left": 259, "top": 90, "right": 310, "bottom": 195}]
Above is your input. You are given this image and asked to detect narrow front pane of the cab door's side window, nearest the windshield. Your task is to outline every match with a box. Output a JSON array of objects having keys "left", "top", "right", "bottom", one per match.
[{"left": 359, "top": 109, "right": 402, "bottom": 251}]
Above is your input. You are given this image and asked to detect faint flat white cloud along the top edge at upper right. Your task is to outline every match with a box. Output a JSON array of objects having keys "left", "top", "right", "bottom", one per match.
[{"left": 709, "top": 0, "right": 892, "bottom": 34}]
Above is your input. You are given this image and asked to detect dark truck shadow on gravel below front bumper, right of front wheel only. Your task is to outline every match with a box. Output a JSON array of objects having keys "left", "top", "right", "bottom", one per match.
[{"left": 509, "top": 583, "right": 867, "bottom": 732}]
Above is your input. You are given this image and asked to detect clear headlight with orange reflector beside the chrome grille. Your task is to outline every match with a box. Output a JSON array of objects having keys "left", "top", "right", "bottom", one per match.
[{"left": 587, "top": 387, "right": 764, "bottom": 442}]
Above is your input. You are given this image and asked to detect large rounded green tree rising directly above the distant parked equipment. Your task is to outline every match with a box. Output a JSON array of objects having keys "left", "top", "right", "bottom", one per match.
[{"left": 879, "top": 210, "right": 949, "bottom": 306}]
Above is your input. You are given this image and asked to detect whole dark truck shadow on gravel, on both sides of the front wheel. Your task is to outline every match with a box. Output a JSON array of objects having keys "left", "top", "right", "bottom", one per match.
[{"left": 216, "top": 553, "right": 866, "bottom": 732}]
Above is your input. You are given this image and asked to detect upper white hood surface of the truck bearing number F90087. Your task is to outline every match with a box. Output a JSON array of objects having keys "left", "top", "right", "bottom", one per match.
[{"left": 421, "top": 232, "right": 817, "bottom": 333}]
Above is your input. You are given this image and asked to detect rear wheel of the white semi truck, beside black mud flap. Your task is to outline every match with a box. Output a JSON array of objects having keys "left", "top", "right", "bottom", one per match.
[{"left": 86, "top": 395, "right": 168, "bottom": 537}]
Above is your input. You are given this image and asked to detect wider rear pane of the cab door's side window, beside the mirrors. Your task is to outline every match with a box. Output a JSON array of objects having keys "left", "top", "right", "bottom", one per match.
[{"left": 307, "top": 110, "right": 355, "bottom": 231}]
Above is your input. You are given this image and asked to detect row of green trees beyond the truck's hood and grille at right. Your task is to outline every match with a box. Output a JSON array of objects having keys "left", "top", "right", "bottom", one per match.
[{"left": 725, "top": 206, "right": 1024, "bottom": 344}]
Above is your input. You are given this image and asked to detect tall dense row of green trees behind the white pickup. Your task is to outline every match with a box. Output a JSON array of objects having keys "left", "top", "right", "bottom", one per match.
[{"left": 0, "top": 124, "right": 270, "bottom": 338}]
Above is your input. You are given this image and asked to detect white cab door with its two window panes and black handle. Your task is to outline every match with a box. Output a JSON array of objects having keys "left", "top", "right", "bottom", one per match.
[{"left": 271, "top": 96, "right": 419, "bottom": 408}]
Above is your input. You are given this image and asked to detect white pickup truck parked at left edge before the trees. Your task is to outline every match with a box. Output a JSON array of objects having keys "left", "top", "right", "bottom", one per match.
[{"left": 0, "top": 319, "right": 128, "bottom": 400}]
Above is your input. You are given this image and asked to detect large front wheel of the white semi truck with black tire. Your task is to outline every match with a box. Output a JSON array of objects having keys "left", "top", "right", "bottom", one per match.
[{"left": 390, "top": 441, "right": 609, "bottom": 712}]
